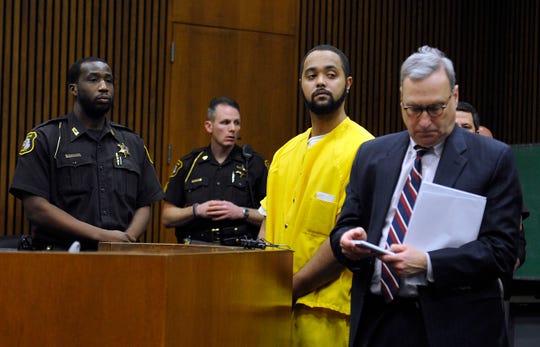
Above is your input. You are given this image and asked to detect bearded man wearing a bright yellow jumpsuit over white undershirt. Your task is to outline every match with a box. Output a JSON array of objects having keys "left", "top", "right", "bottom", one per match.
[{"left": 259, "top": 45, "right": 373, "bottom": 347}]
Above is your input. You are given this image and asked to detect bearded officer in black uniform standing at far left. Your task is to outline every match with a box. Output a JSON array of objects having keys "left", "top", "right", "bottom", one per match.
[{"left": 10, "top": 57, "right": 164, "bottom": 250}]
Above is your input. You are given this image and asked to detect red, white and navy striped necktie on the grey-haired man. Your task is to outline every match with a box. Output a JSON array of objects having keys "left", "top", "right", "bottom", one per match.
[{"left": 381, "top": 146, "right": 429, "bottom": 302}]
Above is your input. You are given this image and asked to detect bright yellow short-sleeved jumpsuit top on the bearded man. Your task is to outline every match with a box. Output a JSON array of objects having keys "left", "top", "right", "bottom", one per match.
[{"left": 261, "top": 117, "right": 373, "bottom": 315}]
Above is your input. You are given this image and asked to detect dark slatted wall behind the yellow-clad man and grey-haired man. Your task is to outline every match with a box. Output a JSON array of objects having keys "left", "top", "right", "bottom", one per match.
[{"left": 298, "top": 0, "right": 540, "bottom": 144}]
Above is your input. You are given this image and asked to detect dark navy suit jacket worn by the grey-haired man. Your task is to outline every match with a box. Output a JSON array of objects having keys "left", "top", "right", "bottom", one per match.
[{"left": 330, "top": 126, "right": 522, "bottom": 347}]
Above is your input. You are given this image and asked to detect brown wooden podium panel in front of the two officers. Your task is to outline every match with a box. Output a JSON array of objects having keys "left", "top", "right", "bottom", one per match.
[{"left": 0, "top": 244, "right": 292, "bottom": 347}]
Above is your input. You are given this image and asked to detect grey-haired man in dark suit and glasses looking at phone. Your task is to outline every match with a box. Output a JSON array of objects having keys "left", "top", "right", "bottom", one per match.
[{"left": 330, "top": 46, "right": 521, "bottom": 347}]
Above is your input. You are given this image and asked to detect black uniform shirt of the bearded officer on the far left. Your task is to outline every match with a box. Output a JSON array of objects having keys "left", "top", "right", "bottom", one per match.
[{"left": 10, "top": 113, "right": 164, "bottom": 249}]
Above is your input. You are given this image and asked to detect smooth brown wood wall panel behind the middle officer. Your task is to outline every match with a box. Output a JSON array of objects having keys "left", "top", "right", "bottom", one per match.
[{"left": 161, "top": 0, "right": 299, "bottom": 242}]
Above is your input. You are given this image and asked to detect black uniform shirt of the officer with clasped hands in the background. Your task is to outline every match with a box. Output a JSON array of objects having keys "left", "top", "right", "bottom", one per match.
[{"left": 165, "top": 145, "right": 268, "bottom": 240}]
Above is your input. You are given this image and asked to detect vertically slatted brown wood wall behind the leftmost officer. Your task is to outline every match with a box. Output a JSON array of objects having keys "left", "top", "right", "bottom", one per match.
[{"left": 0, "top": 0, "right": 168, "bottom": 240}]
